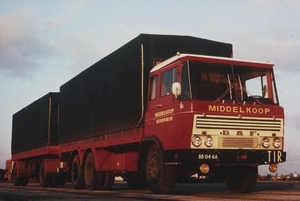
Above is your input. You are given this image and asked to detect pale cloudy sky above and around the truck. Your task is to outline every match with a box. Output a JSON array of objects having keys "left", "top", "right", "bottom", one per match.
[{"left": 0, "top": 0, "right": 300, "bottom": 174}]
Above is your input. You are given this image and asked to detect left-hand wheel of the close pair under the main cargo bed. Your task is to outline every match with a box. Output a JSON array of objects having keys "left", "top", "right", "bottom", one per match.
[{"left": 71, "top": 155, "right": 84, "bottom": 189}]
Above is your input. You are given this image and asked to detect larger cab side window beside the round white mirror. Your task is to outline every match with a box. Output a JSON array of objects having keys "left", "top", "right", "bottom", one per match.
[{"left": 160, "top": 67, "right": 177, "bottom": 96}]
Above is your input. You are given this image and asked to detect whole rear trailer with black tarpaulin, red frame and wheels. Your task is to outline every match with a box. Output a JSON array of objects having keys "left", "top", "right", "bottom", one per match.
[{"left": 11, "top": 93, "right": 59, "bottom": 186}]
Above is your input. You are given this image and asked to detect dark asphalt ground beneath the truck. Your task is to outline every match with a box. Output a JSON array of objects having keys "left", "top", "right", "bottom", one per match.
[{"left": 0, "top": 181, "right": 300, "bottom": 201}]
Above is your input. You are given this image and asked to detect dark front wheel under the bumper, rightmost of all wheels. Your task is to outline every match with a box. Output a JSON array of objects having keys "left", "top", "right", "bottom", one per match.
[{"left": 225, "top": 166, "right": 258, "bottom": 193}]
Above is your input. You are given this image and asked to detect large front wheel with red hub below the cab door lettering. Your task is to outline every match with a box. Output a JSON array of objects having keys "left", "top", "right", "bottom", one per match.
[{"left": 146, "top": 145, "right": 177, "bottom": 194}]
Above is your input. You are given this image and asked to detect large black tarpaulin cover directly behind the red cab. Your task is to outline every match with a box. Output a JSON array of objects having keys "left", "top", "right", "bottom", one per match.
[{"left": 59, "top": 34, "right": 232, "bottom": 143}]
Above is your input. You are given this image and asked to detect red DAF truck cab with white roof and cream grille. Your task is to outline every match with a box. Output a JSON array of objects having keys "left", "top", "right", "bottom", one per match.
[{"left": 145, "top": 53, "right": 286, "bottom": 192}]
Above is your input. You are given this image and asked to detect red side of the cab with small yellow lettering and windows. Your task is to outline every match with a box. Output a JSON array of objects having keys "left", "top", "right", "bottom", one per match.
[{"left": 145, "top": 63, "right": 179, "bottom": 149}]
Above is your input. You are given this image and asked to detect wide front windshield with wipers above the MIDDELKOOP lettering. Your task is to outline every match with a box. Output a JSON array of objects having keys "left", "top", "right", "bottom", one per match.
[{"left": 180, "top": 61, "right": 278, "bottom": 104}]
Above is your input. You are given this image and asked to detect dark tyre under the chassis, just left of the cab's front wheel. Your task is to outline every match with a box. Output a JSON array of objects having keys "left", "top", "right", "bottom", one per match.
[{"left": 126, "top": 170, "right": 146, "bottom": 189}]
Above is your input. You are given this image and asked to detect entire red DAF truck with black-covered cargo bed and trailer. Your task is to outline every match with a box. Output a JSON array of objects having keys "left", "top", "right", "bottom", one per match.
[{"left": 12, "top": 34, "right": 286, "bottom": 193}]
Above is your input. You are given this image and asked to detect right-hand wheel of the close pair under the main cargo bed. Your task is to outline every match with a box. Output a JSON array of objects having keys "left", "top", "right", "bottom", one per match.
[{"left": 84, "top": 153, "right": 99, "bottom": 190}]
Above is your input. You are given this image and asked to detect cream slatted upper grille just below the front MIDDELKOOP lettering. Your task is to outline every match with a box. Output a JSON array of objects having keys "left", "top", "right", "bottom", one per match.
[{"left": 196, "top": 116, "right": 282, "bottom": 132}]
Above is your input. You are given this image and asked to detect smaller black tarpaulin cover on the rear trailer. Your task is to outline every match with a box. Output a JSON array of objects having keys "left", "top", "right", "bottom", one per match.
[{"left": 11, "top": 93, "right": 59, "bottom": 154}]
